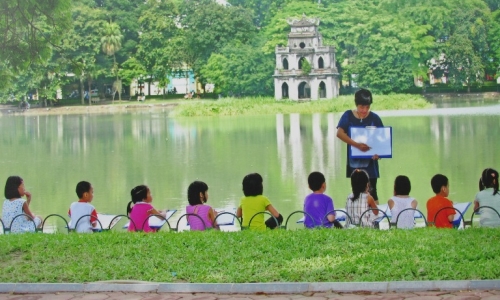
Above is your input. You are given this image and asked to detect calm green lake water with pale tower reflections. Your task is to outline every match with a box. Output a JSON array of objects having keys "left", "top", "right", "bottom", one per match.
[{"left": 0, "top": 104, "right": 500, "bottom": 226}]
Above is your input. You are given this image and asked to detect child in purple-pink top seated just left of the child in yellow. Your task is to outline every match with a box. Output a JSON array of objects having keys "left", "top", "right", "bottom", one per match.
[{"left": 186, "top": 181, "right": 218, "bottom": 230}]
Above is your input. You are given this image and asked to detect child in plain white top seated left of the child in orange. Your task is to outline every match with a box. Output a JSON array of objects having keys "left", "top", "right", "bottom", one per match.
[{"left": 387, "top": 175, "right": 417, "bottom": 229}]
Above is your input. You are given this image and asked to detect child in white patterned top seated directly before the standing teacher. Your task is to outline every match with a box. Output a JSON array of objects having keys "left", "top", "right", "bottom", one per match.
[{"left": 345, "top": 169, "right": 378, "bottom": 227}]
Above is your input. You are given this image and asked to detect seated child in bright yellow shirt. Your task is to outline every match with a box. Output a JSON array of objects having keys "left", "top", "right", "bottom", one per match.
[{"left": 236, "top": 173, "right": 283, "bottom": 230}]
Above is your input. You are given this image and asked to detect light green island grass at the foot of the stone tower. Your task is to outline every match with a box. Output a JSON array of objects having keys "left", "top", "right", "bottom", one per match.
[{"left": 171, "top": 94, "right": 432, "bottom": 117}]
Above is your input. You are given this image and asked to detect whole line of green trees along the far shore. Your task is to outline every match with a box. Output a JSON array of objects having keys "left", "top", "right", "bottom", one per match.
[{"left": 0, "top": 0, "right": 500, "bottom": 103}]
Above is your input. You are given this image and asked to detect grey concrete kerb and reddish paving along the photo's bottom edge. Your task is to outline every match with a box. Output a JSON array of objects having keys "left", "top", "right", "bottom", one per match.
[{"left": 0, "top": 280, "right": 500, "bottom": 300}]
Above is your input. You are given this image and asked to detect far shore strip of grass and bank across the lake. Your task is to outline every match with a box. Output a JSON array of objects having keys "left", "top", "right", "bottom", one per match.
[{"left": 4, "top": 92, "right": 500, "bottom": 117}]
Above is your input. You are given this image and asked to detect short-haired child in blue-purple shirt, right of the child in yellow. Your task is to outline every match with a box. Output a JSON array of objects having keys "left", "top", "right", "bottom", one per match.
[{"left": 304, "top": 172, "right": 342, "bottom": 228}]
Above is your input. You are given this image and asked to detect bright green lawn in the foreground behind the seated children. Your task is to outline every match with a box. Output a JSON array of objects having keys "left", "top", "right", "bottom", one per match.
[{"left": 0, "top": 228, "right": 500, "bottom": 283}]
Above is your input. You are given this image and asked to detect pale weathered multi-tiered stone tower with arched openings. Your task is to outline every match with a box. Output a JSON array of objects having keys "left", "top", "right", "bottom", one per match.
[{"left": 273, "top": 15, "right": 339, "bottom": 100}]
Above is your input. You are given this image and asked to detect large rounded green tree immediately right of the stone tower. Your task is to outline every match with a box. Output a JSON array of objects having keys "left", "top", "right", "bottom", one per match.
[{"left": 328, "top": 0, "right": 434, "bottom": 93}]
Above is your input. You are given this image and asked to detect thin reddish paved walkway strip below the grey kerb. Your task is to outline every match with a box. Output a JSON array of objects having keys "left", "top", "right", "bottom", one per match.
[{"left": 0, "top": 290, "right": 500, "bottom": 300}]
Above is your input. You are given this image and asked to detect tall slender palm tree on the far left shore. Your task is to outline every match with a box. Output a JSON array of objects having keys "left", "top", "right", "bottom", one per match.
[{"left": 101, "top": 20, "right": 123, "bottom": 103}]
